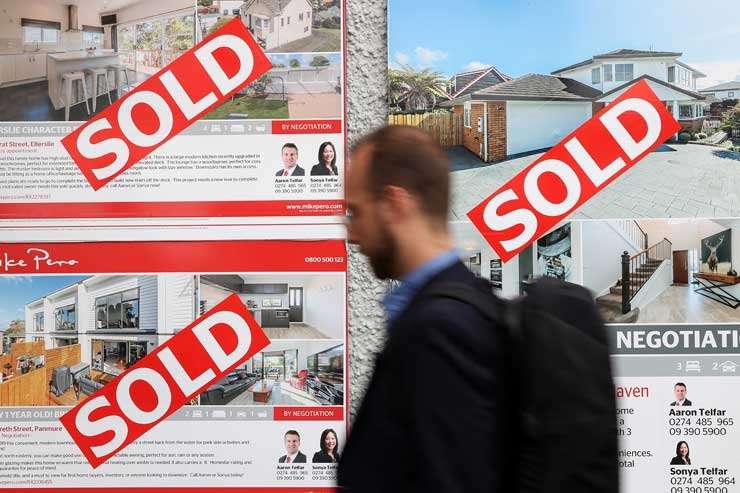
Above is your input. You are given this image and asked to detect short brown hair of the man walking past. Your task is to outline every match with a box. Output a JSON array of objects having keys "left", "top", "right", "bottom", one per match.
[{"left": 355, "top": 125, "right": 450, "bottom": 223}]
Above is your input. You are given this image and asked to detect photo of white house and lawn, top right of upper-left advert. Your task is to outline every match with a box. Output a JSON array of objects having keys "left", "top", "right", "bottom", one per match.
[{"left": 197, "top": 0, "right": 342, "bottom": 53}]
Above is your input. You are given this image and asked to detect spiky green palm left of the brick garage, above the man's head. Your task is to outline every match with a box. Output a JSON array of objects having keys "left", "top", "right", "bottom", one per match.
[{"left": 388, "top": 65, "right": 447, "bottom": 111}]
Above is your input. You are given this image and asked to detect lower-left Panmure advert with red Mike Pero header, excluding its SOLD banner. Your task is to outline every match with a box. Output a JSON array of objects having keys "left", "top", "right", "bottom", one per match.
[{"left": 0, "top": 240, "right": 348, "bottom": 491}]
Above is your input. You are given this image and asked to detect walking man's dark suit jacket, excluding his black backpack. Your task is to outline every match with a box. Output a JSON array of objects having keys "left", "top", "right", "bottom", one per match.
[{"left": 338, "top": 263, "right": 504, "bottom": 493}]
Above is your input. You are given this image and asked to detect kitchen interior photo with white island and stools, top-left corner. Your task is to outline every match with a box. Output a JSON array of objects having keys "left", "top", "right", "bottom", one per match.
[{"left": 0, "top": 0, "right": 195, "bottom": 122}]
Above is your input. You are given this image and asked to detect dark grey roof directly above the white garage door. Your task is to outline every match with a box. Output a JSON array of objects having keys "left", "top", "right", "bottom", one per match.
[{"left": 445, "top": 74, "right": 601, "bottom": 106}]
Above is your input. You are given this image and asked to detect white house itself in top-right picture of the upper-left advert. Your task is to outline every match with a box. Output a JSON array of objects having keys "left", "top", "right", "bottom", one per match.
[{"left": 241, "top": 0, "right": 313, "bottom": 50}]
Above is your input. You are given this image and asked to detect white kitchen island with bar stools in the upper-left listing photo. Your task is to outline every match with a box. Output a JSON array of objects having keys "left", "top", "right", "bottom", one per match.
[{"left": 46, "top": 50, "right": 120, "bottom": 110}]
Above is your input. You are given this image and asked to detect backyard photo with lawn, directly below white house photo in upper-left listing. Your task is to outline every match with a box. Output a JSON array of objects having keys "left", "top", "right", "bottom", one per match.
[{"left": 203, "top": 53, "right": 342, "bottom": 120}]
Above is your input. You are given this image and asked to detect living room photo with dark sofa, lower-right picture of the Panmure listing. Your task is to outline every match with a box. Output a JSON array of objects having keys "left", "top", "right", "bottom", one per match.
[{"left": 200, "top": 340, "right": 345, "bottom": 406}]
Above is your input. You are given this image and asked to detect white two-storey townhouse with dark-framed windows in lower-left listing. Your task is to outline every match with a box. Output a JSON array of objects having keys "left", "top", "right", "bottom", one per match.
[{"left": 25, "top": 274, "right": 198, "bottom": 376}]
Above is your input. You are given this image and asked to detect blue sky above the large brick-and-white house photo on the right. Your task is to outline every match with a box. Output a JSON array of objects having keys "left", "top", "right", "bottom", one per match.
[{"left": 388, "top": 0, "right": 740, "bottom": 88}]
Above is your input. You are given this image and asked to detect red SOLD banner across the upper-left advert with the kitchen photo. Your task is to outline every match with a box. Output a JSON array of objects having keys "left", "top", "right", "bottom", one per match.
[{"left": 62, "top": 18, "right": 272, "bottom": 190}]
